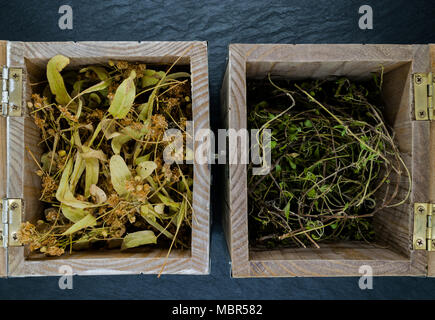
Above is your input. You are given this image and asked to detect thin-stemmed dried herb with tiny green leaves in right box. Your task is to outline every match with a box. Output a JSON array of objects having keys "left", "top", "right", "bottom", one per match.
[{"left": 248, "top": 73, "right": 411, "bottom": 247}]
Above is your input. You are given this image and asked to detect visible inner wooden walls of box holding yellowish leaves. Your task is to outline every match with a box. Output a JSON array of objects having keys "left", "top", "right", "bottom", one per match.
[{"left": 23, "top": 56, "right": 191, "bottom": 260}]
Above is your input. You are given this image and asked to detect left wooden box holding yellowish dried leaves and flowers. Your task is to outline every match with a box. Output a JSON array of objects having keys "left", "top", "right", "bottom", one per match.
[{"left": 0, "top": 41, "right": 210, "bottom": 277}]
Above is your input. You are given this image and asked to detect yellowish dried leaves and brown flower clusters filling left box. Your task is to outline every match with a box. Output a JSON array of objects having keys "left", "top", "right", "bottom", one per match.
[{"left": 18, "top": 55, "right": 193, "bottom": 262}]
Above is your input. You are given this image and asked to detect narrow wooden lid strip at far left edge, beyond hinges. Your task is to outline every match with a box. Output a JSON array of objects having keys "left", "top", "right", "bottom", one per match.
[{"left": 0, "top": 41, "right": 7, "bottom": 277}]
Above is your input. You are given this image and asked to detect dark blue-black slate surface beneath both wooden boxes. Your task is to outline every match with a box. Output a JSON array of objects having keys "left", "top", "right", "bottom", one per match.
[{"left": 0, "top": 0, "right": 435, "bottom": 299}]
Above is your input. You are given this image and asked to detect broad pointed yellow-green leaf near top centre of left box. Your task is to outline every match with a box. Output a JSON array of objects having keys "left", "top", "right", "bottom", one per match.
[{"left": 108, "top": 70, "right": 136, "bottom": 119}]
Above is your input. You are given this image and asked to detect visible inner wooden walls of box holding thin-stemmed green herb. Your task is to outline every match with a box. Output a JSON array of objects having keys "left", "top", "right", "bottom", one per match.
[{"left": 246, "top": 61, "right": 412, "bottom": 262}]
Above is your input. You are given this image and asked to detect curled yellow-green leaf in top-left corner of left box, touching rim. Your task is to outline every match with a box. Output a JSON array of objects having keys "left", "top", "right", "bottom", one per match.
[{"left": 47, "top": 55, "right": 71, "bottom": 105}]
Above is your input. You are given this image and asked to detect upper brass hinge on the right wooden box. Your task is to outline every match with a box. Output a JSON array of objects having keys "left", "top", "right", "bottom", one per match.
[{"left": 414, "top": 72, "right": 435, "bottom": 120}]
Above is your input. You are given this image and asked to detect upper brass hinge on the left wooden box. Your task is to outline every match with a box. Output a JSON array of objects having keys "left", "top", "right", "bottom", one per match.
[{"left": 1, "top": 66, "right": 23, "bottom": 117}]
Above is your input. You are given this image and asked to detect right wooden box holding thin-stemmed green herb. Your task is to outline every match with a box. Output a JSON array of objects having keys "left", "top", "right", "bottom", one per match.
[{"left": 221, "top": 44, "right": 435, "bottom": 277}]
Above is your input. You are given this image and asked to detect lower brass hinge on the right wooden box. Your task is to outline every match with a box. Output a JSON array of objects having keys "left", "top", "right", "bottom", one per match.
[{"left": 412, "top": 203, "right": 435, "bottom": 251}]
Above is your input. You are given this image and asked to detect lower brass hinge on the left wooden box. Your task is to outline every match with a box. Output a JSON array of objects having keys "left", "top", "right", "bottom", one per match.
[{"left": 0, "top": 199, "right": 23, "bottom": 248}]
